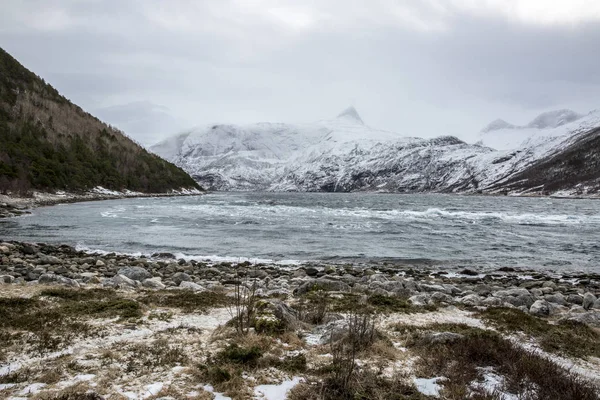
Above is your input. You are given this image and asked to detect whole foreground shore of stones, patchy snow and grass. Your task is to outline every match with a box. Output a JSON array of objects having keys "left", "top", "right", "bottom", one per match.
[{"left": 0, "top": 241, "right": 600, "bottom": 399}]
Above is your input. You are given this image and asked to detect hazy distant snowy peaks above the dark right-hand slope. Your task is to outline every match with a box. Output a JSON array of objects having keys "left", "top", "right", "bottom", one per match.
[{"left": 479, "top": 110, "right": 598, "bottom": 150}]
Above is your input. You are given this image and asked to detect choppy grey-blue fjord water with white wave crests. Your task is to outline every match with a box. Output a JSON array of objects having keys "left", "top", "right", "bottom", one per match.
[{"left": 0, "top": 193, "right": 600, "bottom": 272}]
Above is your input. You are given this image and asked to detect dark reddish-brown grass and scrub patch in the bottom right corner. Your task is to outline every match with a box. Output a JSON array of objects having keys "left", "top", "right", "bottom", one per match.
[{"left": 411, "top": 324, "right": 598, "bottom": 400}]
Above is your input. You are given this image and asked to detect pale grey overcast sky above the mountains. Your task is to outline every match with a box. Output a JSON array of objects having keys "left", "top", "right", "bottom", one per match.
[{"left": 0, "top": 0, "right": 600, "bottom": 144}]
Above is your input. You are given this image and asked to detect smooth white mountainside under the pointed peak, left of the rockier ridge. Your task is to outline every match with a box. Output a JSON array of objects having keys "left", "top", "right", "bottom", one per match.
[{"left": 151, "top": 107, "right": 414, "bottom": 190}]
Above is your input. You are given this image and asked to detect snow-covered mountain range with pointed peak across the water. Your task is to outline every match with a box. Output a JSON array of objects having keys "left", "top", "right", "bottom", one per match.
[{"left": 151, "top": 107, "right": 600, "bottom": 193}]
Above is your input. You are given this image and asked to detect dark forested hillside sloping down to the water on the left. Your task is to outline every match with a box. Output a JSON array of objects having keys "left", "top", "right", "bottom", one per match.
[{"left": 0, "top": 48, "right": 199, "bottom": 193}]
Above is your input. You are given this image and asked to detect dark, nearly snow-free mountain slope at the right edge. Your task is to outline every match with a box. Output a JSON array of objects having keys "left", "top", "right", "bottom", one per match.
[{"left": 491, "top": 128, "right": 600, "bottom": 195}]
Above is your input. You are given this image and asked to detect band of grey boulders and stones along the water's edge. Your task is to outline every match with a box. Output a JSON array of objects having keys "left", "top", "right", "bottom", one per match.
[{"left": 0, "top": 242, "right": 600, "bottom": 318}]
